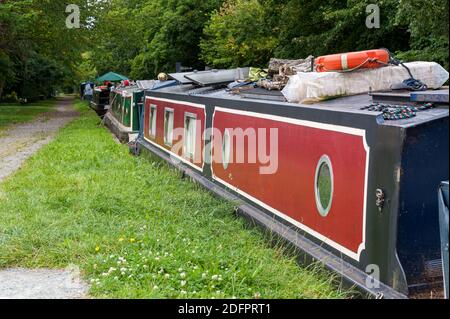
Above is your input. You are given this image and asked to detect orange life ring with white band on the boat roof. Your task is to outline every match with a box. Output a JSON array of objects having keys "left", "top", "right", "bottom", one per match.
[{"left": 315, "top": 49, "right": 390, "bottom": 72}]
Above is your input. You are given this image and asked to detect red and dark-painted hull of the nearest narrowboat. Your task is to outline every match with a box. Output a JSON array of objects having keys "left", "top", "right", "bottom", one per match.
[{"left": 138, "top": 89, "right": 449, "bottom": 298}]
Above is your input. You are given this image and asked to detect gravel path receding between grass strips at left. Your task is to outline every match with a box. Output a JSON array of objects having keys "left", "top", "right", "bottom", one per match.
[{"left": 0, "top": 98, "right": 78, "bottom": 182}]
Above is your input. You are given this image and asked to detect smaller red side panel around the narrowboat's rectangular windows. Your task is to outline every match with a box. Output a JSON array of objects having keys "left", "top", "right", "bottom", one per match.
[{"left": 144, "top": 98, "right": 205, "bottom": 168}]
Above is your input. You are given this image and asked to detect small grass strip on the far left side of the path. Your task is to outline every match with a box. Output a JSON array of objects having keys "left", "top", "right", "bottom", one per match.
[{"left": 0, "top": 100, "right": 55, "bottom": 131}]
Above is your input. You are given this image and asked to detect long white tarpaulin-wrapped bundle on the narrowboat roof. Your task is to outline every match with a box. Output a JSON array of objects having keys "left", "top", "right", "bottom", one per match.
[{"left": 282, "top": 62, "right": 449, "bottom": 103}]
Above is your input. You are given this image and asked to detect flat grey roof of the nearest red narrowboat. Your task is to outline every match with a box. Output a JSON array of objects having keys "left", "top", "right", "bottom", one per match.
[{"left": 146, "top": 84, "right": 449, "bottom": 128}]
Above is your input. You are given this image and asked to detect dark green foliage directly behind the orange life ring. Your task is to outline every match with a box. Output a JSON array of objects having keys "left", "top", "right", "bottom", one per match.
[{"left": 276, "top": 0, "right": 408, "bottom": 58}]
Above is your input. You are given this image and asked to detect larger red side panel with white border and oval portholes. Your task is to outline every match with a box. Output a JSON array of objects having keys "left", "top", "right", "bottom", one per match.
[{"left": 212, "top": 110, "right": 368, "bottom": 253}]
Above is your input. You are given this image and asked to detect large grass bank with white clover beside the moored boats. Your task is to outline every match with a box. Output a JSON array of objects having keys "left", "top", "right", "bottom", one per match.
[{"left": 0, "top": 102, "right": 348, "bottom": 298}]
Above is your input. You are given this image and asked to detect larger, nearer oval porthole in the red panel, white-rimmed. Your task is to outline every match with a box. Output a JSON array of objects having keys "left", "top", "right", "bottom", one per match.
[{"left": 314, "top": 155, "right": 333, "bottom": 217}]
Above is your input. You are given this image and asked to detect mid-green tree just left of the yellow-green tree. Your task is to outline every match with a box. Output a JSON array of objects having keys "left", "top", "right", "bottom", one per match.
[{"left": 132, "top": 0, "right": 222, "bottom": 77}]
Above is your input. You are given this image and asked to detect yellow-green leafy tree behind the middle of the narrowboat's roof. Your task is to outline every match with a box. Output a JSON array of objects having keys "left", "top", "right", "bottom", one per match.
[{"left": 200, "top": 0, "right": 279, "bottom": 68}]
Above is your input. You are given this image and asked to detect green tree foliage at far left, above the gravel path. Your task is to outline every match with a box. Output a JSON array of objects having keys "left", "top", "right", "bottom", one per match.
[{"left": 0, "top": 0, "right": 89, "bottom": 99}]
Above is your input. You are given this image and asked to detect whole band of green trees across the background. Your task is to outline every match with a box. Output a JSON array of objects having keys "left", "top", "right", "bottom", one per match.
[{"left": 0, "top": 0, "right": 449, "bottom": 98}]
